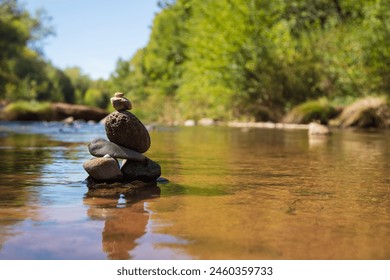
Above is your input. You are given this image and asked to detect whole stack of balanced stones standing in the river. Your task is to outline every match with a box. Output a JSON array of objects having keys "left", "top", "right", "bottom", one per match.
[{"left": 83, "top": 92, "right": 161, "bottom": 183}]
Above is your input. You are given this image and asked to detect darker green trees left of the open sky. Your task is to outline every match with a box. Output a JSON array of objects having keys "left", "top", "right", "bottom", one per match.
[{"left": 0, "top": 0, "right": 80, "bottom": 106}]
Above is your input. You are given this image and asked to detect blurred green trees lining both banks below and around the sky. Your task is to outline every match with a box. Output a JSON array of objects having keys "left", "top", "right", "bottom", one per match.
[{"left": 0, "top": 0, "right": 390, "bottom": 123}]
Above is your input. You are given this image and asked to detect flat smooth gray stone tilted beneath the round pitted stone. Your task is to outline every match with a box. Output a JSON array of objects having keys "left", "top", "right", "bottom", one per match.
[{"left": 88, "top": 138, "right": 146, "bottom": 162}]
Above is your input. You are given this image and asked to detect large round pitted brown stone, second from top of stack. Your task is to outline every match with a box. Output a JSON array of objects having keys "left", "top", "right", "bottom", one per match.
[{"left": 105, "top": 111, "right": 150, "bottom": 153}]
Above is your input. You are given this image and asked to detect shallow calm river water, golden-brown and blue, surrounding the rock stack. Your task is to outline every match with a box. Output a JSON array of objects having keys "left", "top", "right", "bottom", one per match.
[{"left": 0, "top": 123, "right": 390, "bottom": 260}]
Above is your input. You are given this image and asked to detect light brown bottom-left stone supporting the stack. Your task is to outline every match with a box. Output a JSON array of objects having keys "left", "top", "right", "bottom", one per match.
[{"left": 83, "top": 156, "right": 123, "bottom": 181}]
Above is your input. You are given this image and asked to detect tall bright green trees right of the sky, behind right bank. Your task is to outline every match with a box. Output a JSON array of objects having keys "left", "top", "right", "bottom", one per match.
[{"left": 110, "top": 0, "right": 390, "bottom": 122}]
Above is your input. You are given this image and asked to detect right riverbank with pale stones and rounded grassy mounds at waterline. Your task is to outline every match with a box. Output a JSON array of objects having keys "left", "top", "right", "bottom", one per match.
[{"left": 182, "top": 96, "right": 390, "bottom": 129}]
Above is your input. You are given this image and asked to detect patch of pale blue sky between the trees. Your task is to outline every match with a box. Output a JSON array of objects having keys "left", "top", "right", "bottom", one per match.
[{"left": 24, "top": 0, "right": 159, "bottom": 79}]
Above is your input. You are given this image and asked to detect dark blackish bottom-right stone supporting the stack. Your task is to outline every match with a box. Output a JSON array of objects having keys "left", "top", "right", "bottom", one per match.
[{"left": 121, "top": 158, "right": 161, "bottom": 181}]
